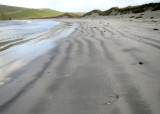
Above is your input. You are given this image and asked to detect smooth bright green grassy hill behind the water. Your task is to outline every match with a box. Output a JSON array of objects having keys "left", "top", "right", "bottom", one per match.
[{"left": 0, "top": 5, "right": 64, "bottom": 20}]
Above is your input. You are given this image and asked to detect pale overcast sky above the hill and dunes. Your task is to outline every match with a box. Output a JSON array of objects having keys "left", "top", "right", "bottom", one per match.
[{"left": 0, "top": 0, "right": 160, "bottom": 12}]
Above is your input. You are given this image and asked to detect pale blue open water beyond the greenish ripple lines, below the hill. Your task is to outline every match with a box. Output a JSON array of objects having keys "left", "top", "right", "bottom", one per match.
[{"left": 0, "top": 20, "right": 59, "bottom": 41}]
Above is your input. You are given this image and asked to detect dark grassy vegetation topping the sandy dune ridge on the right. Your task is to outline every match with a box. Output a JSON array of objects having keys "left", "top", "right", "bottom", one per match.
[{"left": 83, "top": 3, "right": 160, "bottom": 16}]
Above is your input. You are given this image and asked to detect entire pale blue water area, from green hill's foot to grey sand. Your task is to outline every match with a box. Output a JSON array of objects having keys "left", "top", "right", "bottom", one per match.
[{"left": 0, "top": 20, "right": 75, "bottom": 86}]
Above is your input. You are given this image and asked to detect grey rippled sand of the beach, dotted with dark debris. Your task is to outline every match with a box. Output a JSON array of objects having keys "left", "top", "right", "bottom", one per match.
[{"left": 0, "top": 19, "right": 160, "bottom": 114}]
